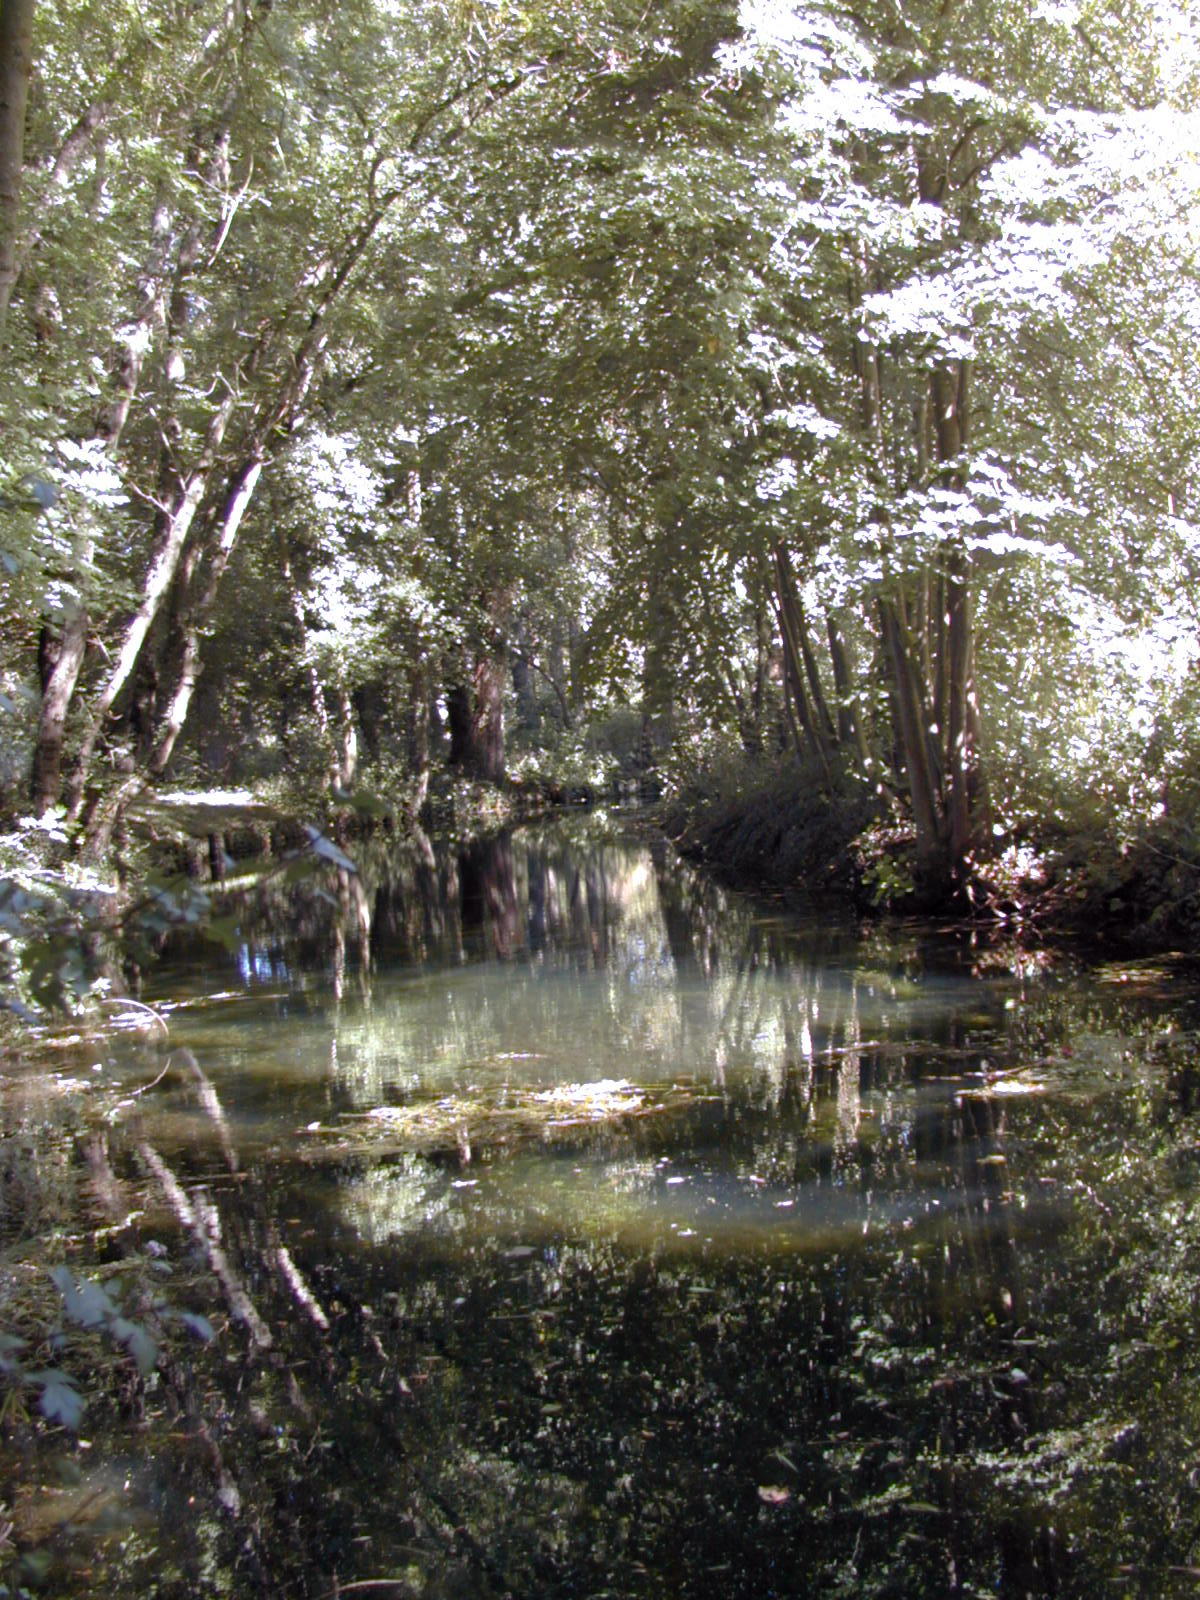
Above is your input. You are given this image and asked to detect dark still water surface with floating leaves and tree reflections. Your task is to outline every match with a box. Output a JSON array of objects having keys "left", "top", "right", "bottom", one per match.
[{"left": 11, "top": 819, "right": 1200, "bottom": 1600}]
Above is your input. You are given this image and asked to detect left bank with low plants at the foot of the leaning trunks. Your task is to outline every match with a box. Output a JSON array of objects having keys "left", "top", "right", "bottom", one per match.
[{"left": 0, "top": 774, "right": 595, "bottom": 1034}]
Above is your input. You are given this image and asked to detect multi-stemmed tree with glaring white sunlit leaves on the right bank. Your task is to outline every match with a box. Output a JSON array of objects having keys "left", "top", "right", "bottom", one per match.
[{"left": 694, "top": 0, "right": 1200, "bottom": 898}]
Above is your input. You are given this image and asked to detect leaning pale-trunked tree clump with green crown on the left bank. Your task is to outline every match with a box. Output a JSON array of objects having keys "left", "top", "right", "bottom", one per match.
[{"left": 9, "top": 3, "right": 752, "bottom": 816}]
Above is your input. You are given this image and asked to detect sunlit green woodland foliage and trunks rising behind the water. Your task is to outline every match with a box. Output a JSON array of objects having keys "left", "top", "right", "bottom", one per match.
[{"left": 0, "top": 0, "right": 1200, "bottom": 901}]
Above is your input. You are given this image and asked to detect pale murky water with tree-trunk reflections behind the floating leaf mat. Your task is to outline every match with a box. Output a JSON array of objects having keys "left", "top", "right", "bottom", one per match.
[{"left": 148, "top": 829, "right": 1036, "bottom": 1158}]
